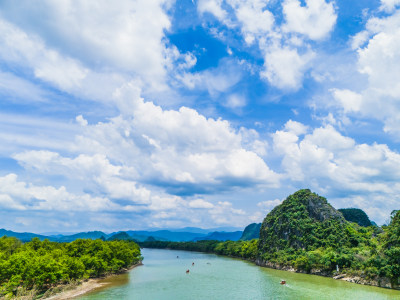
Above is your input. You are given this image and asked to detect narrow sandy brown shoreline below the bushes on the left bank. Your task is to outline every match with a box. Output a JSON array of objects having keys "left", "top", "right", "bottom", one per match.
[{"left": 40, "top": 262, "right": 143, "bottom": 300}]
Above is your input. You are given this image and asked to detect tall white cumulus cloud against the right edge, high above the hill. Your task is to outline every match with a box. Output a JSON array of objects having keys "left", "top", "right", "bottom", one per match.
[{"left": 332, "top": 11, "right": 400, "bottom": 136}]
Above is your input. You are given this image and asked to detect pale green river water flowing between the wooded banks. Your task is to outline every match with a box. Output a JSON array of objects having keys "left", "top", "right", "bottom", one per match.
[{"left": 79, "top": 249, "right": 400, "bottom": 300}]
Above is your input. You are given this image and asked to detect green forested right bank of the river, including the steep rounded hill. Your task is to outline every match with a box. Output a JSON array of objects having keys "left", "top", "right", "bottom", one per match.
[{"left": 141, "top": 190, "right": 400, "bottom": 288}]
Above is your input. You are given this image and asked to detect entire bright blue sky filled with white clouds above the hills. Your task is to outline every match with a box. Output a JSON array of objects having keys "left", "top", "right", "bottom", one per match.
[{"left": 0, "top": 0, "right": 400, "bottom": 232}]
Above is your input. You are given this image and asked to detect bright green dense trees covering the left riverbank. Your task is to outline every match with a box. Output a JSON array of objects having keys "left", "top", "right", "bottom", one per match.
[{"left": 0, "top": 236, "right": 141, "bottom": 299}]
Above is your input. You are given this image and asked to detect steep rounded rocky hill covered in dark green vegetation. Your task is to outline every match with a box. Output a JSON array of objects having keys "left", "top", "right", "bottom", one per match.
[{"left": 259, "top": 189, "right": 347, "bottom": 256}]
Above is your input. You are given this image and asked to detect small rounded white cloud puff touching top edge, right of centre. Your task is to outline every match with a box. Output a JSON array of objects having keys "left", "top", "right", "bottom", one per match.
[{"left": 282, "top": 0, "right": 337, "bottom": 40}]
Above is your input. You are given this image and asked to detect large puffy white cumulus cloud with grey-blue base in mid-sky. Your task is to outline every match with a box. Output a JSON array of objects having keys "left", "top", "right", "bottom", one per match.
[{"left": 77, "top": 86, "right": 279, "bottom": 193}]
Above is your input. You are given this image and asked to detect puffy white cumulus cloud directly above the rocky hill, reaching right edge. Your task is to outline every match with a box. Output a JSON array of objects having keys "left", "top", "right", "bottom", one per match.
[{"left": 273, "top": 121, "right": 400, "bottom": 222}]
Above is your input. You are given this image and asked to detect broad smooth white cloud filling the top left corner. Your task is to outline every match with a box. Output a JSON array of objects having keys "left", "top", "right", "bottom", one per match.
[{"left": 2, "top": 0, "right": 171, "bottom": 84}]
